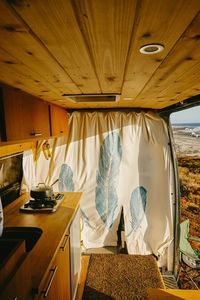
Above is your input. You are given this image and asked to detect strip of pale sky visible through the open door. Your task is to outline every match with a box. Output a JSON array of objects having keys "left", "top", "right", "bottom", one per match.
[{"left": 171, "top": 106, "right": 200, "bottom": 124}]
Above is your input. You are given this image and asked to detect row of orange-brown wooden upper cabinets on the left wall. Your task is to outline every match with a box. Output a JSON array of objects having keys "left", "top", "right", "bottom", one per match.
[{"left": 0, "top": 87, "right": 68, "bottom": 142}]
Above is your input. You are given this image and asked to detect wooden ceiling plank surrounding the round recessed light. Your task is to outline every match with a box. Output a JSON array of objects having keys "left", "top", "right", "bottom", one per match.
[{"left": 122, "top": 0, "right": 200, "bottom": 101}]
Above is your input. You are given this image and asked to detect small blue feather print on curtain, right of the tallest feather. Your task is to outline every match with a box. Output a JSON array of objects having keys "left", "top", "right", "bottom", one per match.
[{"left": 127, "top": 186, "right": 147, "bottom": 237}]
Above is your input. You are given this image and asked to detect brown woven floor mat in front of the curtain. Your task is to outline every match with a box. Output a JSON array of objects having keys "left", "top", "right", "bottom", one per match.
[{"left": 82, "top": 254, "right": 164, "bottom": 300}]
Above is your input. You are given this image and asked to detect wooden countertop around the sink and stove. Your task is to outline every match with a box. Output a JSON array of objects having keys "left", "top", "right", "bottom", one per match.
[{"left": 1, "top": 192, "right": 82, "bottom": 298}]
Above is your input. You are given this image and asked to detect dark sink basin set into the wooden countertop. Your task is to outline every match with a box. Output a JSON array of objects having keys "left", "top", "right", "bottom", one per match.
[{"left": 0, "top": 227, "right": 42, "bottom": 252}]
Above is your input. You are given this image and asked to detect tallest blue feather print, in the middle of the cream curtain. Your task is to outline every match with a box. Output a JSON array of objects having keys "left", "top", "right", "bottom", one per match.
[{"left": 95, "top": 132, "right": 122, "bottom": 228}]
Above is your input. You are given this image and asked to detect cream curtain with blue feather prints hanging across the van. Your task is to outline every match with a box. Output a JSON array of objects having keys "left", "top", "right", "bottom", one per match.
[{"left": 23, "top": 112, "right": 173, "bottom": 269}]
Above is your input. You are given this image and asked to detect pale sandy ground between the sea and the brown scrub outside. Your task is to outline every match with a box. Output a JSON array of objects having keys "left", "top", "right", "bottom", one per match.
[{"left": 173, "top": 127, "right": 200, "bottom": 157}]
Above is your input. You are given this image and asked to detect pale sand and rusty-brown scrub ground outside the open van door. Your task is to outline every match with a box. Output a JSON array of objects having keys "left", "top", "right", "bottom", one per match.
[{"left": 173, "top": 127, "right": 200, "bottom": 289}]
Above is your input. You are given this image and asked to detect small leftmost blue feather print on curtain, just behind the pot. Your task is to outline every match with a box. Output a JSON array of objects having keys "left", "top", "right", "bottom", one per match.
[{"left": 58, "top": 164, "right": 74, "bottom": 192}]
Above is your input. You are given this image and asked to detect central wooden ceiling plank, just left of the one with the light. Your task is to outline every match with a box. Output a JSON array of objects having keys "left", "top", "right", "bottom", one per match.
[{"left": 72, "top": 0, "right": 137, "bottom": 93}]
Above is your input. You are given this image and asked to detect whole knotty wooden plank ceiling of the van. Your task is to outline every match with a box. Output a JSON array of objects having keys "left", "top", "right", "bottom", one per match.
[{"left": 0, "top": 0, "right": 200, "bottom": 109}]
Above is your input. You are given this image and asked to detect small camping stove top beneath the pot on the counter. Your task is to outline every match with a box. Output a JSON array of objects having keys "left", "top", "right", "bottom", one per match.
[{"left": 19, "top": 193, "right": 64, "bottom": 213}]
